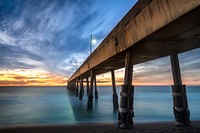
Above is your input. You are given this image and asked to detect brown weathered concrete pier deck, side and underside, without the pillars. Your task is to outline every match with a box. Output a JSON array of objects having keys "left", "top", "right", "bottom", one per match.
[{"left": 68, "top": 0, "right": 200, "bottom": 83}]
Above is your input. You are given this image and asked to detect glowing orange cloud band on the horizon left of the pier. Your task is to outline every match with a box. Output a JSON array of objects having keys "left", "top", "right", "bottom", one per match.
[{"left": 0, "top": 69, "right": 67, "bottom": 86}]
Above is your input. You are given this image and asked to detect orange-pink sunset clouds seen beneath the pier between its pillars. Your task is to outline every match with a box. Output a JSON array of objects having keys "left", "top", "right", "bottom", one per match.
[{"left": 92, "top": 67, "right": 200, "bottom": 86}]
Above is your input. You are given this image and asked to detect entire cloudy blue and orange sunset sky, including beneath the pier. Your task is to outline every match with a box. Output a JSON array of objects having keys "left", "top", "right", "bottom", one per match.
[{"left": 0, "top": 0, "right": 200, "bottom": 86}]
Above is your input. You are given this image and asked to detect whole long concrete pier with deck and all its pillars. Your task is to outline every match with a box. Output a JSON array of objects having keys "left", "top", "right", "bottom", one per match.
[{"left": 67, "top": 0, "right": 200, "bottom": 128}]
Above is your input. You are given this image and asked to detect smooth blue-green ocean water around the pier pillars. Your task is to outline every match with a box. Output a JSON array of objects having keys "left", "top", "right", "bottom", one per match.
[{"left": 0, "top": 86, "right": 200, "bottom": 126}]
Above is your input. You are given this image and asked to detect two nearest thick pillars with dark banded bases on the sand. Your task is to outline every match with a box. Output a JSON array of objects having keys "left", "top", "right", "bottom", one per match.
[{"left": 118, "top": 51, "right": 191, "bottom": 129}]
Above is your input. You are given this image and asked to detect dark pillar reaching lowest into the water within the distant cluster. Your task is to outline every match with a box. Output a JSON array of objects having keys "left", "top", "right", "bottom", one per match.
[{"left": 87, "top": 70, "right": 94, "bottom": 110}]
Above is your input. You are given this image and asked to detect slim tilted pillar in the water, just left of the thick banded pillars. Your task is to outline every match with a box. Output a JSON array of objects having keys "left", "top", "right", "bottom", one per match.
[{"left": 111, "top": 70, "right": 118, "bottom": 109}]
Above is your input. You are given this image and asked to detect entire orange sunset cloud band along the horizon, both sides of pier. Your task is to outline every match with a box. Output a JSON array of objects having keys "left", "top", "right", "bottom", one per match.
[{"left": 0, "top": 66, "right": 200, "bottom": 86}]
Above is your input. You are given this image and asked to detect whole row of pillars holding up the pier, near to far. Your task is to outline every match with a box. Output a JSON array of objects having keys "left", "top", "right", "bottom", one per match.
[{"left": 68, "top": 51, "right": 191, "bottom": 129}]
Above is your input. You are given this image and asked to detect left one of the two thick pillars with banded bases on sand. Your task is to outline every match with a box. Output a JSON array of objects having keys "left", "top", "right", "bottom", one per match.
[{"left": 118, "top": 51, "right": 134, "bottom": 129}]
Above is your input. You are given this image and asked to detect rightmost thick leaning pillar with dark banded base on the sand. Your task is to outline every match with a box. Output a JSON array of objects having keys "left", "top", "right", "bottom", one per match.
[{"left": 170, "top": 53, "right": 191, "bottom": 126}]
